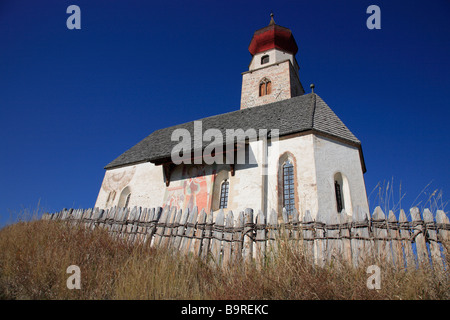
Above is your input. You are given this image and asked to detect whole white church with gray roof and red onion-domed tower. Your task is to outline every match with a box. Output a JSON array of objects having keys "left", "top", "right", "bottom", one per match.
[{"left": 95, "top": 15, "right": 369, "bottom": 219}]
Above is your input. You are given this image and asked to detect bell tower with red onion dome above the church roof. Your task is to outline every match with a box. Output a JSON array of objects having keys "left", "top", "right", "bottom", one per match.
[{"left": 241, "top": 13, "right": 305, "bottom": 109}]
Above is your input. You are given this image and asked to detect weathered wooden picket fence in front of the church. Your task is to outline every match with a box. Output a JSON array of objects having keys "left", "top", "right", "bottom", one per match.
[{"left": 42, "top": 207, "right": 450, "bottom": 270}]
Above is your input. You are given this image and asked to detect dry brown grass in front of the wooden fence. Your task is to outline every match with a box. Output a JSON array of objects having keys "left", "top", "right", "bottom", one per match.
[{"left": 0, "top": 221, "right": 450, "bottom": 300}]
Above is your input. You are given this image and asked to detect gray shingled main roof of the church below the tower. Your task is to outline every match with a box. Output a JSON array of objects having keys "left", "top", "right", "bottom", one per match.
[{"left": 105, "top": 93, "right": 361, "bottom": 169}]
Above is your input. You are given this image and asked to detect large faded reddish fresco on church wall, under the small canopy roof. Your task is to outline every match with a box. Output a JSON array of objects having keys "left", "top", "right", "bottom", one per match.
[{"left": 164, "top": 165, "right": 215, "bottom": 212}]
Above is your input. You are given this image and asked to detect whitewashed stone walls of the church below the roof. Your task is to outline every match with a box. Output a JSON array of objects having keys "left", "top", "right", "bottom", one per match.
[{"left": 95, "top": 134, "right": 368, "bottom": 219}]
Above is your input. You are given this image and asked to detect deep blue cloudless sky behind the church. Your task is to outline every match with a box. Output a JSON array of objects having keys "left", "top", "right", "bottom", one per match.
[{"left": 0, "top": 0, "right": 450, "bottom": 226}]
